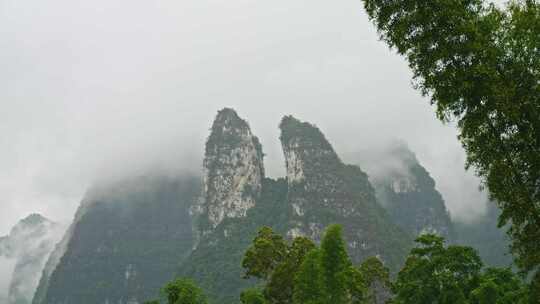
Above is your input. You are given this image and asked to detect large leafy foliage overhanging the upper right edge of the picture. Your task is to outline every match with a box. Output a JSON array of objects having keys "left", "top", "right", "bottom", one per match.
[{"left": 363, "top": 0, "right": 540, "bottom": 285}]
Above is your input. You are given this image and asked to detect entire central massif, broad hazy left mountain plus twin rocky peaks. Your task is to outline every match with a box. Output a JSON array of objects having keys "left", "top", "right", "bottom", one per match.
[{"left": 34, "top": 108, "right": 413, "bottom": 304}]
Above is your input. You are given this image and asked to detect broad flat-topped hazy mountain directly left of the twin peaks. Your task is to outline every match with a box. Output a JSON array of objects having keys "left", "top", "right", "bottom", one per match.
[{"left": 33, "top": 175, "right": 201, "bottom": 304}]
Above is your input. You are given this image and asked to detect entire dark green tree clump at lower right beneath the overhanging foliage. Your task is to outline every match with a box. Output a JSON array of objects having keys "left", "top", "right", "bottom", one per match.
[{"left": 393, "top": 234, "right": 529, "bottom": 304}]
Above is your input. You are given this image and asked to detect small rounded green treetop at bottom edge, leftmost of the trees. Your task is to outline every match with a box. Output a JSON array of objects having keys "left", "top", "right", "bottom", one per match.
[{"left": 163, "top": 279, "right": 208, "bottom": 304}]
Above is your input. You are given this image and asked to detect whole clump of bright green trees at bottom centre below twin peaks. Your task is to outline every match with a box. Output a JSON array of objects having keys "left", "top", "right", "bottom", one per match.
[{"left": 243, "top": 225, "right": 365, "bottom": 304}]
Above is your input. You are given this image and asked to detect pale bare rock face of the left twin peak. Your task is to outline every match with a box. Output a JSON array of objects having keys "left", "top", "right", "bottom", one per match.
[{"left": 199, "top": 109, "right": 264, "bottom": 230}]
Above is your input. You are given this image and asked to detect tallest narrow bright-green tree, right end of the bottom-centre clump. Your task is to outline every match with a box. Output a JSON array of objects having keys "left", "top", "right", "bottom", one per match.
[{"left": 321, "top": 225, "right": 352, "bottom": 303}]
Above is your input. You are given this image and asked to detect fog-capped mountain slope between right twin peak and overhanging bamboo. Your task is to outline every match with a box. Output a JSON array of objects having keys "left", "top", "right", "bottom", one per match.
[{"left": 347, "top": 142, "right": 512, "bottom": 267}]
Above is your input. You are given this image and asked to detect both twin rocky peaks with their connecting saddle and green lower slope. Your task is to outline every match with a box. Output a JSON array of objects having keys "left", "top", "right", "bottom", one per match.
[{"left": 178, "top": 109, "right": 411, "bottom": 303}]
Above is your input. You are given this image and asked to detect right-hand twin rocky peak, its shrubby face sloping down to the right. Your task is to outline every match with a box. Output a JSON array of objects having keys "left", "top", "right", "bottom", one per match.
[{"left": 280, "top": 116, "right": 410, "bottom": 269}]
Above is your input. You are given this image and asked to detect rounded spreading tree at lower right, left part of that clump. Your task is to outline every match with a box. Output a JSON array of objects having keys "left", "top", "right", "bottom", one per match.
[{"left": 393, "top": 234, "right": 482, "bottom": 304}]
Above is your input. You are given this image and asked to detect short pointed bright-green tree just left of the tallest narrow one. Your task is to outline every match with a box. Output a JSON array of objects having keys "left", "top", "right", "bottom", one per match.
[{"left": 293, "top": 249, "right": 330, "bottom": 304}]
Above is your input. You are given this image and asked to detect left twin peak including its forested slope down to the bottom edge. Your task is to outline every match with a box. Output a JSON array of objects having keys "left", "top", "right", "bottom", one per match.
[{"left": 178, "top": 109, "right": 280, "bottom": 303}]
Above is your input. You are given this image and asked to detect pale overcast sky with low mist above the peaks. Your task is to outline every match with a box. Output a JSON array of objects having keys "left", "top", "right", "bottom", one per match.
[{"left": 0, "top": 0, "right": 506, "bottom": 235}]
